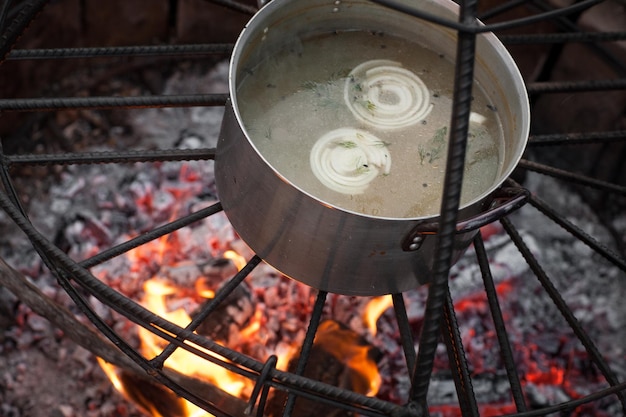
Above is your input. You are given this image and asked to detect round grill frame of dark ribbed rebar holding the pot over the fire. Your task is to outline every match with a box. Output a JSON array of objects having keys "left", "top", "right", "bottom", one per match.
[{"left": 0, "top": 0, "right": 626, "bottom": 417}]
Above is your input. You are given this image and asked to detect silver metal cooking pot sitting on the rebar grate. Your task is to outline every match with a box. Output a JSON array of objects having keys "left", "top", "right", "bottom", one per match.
[{"left": 215, "top": 0, "right": 530, "bottom": 295}]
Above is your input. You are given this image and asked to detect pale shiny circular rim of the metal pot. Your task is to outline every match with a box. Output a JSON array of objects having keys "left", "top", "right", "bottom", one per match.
[{"left": 228, "top": 0, "right": 530, "bottom": 222}]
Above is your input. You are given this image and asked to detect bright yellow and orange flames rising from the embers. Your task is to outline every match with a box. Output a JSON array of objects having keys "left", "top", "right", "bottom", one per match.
[{"left": 101, "top": 226, "right": 382, "bottom": 417}]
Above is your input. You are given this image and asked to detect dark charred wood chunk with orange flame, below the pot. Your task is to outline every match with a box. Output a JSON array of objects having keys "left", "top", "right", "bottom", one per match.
[{"left": 267, "top": 320, "right": 380, "bottom": 417}]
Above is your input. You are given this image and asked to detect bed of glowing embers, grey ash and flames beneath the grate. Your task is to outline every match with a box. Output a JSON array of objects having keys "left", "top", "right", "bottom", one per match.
[{"left": 0, "top": 1, "right": 626, "bottom": 416}]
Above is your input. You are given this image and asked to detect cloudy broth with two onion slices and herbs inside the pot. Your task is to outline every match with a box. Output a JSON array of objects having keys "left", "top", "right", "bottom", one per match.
[{"left": 237, "top": 31, "right": 503, "bottom": 218}]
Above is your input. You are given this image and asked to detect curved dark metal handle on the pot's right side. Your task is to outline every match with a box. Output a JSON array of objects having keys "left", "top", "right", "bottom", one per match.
[{"left": 402, "top": 187, "right": 530, "bottom": 251}]
